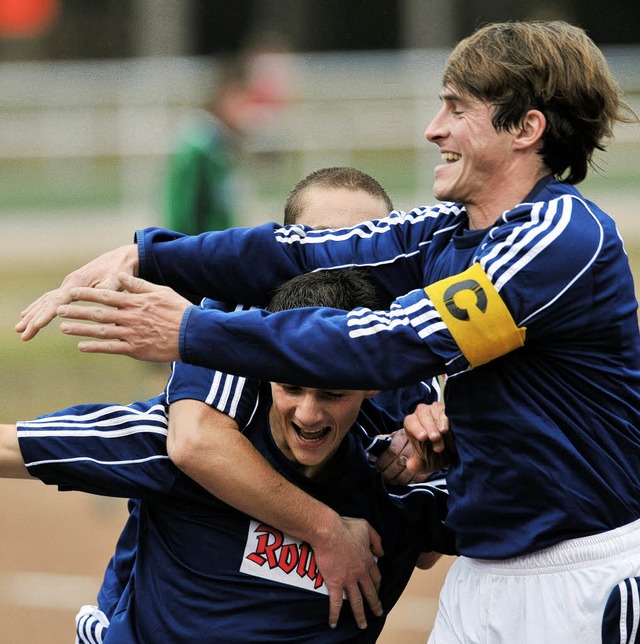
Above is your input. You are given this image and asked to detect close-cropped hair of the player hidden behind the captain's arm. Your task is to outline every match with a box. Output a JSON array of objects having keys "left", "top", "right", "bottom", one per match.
[{"left": 284, "top": 166, "right": 393, "bottom": 226}]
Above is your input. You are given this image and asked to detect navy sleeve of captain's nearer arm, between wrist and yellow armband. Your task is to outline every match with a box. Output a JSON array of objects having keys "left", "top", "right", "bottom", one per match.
[{"left": 179, "top": 295, "right": 445, "bottom": 389}]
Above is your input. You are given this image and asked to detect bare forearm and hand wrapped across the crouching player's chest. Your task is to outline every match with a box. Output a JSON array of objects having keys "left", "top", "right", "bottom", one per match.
[{"left": 167, "top": 400, "right": 383, "bottom": 628}]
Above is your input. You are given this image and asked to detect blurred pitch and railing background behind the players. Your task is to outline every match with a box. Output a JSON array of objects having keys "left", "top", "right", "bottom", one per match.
[{"left": 0, "top": 0, "right": 640, "bottom": 644}]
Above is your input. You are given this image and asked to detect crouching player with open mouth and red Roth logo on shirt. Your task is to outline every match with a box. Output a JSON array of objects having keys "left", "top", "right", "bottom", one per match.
[{"left": 0, "top": 270, "right": 452, "bottom": 643}]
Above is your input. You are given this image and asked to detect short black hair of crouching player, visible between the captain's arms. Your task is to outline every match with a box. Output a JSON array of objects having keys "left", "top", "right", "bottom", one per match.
[{"left": 267, "top": 268, "right": 379, "bottom": 312}]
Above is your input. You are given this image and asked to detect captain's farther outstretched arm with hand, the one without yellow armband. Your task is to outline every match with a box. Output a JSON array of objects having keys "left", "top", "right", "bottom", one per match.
[{"left": 16, "top": 209, "right": 440, "bottom": 348}]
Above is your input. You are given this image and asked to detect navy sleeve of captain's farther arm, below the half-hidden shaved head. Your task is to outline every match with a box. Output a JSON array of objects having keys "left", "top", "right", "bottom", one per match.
[{"left": 136, "top": 212, "right": 434, "bottom": 305}]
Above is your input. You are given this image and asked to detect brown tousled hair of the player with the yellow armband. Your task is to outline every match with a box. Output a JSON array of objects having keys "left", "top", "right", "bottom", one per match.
[{"left": 443, "top": 20, "right": 637, "bottom": 184}]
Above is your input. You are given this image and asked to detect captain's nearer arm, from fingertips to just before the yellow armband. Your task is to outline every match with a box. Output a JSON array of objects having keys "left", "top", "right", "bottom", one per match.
[{"left": 51, "top": 274, "right": 444, "bottom": 390}]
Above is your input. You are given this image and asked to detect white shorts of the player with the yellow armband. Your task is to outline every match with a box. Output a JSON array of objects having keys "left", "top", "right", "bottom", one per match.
[{"left": 429, "top": 520, "right": 640, "bottom": 644}]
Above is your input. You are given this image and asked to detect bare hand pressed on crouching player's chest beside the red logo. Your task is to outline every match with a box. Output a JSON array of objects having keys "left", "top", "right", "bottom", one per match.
[{"left": 311, "top": 517, "right": 384, "bottom": 628}]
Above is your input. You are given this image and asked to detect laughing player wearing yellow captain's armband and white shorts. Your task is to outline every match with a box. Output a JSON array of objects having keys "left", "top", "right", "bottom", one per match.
[{"left": 17, "top": 21, "right": 640, "bottom": 643}]
